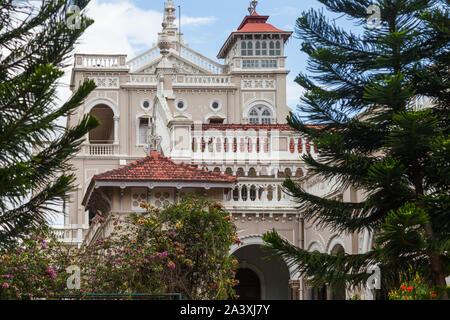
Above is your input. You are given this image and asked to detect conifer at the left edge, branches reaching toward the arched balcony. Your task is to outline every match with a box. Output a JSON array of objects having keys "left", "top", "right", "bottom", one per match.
[{"left": 0, "top": 0, "right": 98, "bottom": 247}]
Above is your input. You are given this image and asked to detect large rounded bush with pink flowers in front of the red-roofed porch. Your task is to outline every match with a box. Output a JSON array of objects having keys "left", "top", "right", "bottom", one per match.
[{"left": 73, "top": 197, "right": 240, "bottom": 299}]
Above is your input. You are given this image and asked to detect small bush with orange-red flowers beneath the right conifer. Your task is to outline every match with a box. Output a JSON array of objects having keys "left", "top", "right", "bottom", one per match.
[{"left": 388, "top": 273, "right": 448, "bottom": 300}]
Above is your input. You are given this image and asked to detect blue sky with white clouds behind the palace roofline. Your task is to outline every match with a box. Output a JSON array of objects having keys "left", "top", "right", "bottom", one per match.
[{"left": 59, "top": 0, "right": 358, "bottom": 109}]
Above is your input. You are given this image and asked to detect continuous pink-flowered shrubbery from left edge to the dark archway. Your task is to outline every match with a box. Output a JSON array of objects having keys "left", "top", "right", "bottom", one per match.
[{"left": 0, "top": 197, "right": 240, "bottom": 300}]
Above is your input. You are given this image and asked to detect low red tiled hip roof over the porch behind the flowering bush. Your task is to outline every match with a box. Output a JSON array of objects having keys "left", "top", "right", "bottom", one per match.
[{"left": 92, "top": 151, "right": 237, "bottom": 183}]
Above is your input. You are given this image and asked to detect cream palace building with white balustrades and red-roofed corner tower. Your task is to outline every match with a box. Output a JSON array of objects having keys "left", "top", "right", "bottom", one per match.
[{"left": 55, "top": 0, "right": 371, "bottom": 300}]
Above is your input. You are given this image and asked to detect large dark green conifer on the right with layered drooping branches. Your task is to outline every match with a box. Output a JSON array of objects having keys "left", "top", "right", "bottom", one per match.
[{"left": 264, "top": 0, "right": 450, "bottom": 299}]
